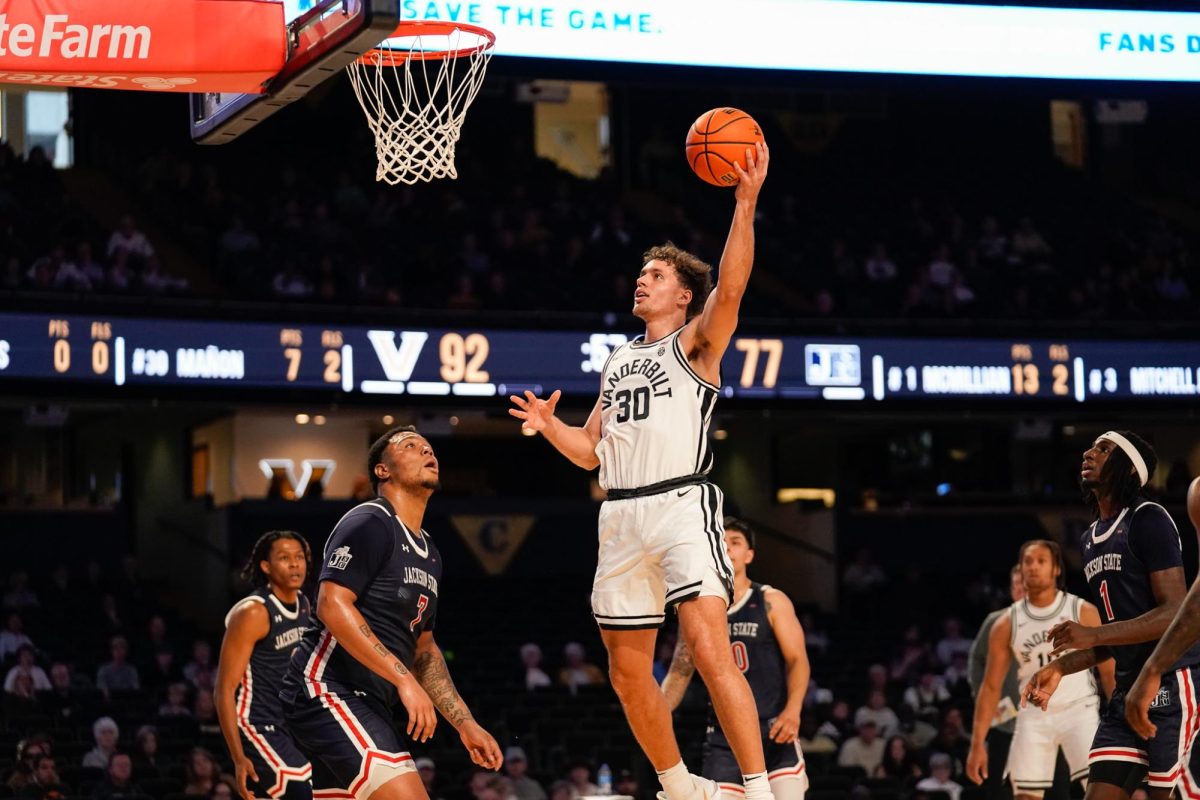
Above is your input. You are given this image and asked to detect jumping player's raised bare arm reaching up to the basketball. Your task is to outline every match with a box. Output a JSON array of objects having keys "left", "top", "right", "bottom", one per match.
[{"left": 680, "top": 142, "right": 770, "bottom": 371}]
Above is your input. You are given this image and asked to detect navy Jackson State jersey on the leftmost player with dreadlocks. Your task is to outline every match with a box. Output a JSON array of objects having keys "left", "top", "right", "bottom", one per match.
[{"left": 226, "top": 587, "right": 312, "bottom": 724}]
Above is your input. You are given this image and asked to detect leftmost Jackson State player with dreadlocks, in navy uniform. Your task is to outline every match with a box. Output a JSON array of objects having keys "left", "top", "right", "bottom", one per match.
[{"left": 215, "top": 530, "right": 312, "bottom": 800}]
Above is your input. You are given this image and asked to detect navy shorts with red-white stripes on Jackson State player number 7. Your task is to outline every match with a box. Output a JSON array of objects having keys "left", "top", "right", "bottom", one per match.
[{"left": 283, "top": 692, "right": 416, "bottom": 800}]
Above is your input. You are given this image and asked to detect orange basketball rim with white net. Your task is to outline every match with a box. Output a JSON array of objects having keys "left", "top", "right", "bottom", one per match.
[{"left": 346, "top": 22, "right": 496, "bottom": 186}]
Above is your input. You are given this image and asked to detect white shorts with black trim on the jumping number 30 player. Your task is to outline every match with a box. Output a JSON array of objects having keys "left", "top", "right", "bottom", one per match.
[{"left": 592, "top": 483, "right": 733, "bottom": 630}]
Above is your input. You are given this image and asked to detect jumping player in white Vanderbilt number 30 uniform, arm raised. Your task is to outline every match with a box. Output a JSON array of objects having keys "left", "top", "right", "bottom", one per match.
[{"left": 509, "top": 144, "right": 770, "bottom": 800}]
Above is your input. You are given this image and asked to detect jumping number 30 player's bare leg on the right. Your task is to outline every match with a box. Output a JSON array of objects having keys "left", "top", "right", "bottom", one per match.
[{"left": 676, "top": 595, "right": 767, "bottom": 775}]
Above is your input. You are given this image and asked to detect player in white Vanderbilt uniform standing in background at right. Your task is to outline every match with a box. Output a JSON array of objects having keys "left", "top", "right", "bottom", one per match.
[{"left": 967, "top": 539, "right": 1114, "bottom": 800}]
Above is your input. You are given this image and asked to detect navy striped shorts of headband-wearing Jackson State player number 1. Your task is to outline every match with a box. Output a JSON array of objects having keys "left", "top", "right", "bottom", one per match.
[{"left": 1087, "top": 666, "right": 1200, "bottom": 798}]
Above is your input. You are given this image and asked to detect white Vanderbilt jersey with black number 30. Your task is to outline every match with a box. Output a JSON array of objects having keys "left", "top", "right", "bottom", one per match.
[{"left": 595, "top": 329, "right": 718, "bottom": 489}]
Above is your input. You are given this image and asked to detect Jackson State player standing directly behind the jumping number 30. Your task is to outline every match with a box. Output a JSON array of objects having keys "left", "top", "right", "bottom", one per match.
[{"left": 662, "top": 517, "right": 811, "bottom": 800}]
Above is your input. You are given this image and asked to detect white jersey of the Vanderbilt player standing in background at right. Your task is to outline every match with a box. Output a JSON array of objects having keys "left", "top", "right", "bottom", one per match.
[{"left": 1010, "top": 590, "right": 1097, "bottom": 714}]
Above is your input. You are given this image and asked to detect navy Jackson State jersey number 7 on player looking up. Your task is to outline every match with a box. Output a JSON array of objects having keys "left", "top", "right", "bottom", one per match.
[{"left": 286, "top": 498, "right": 442, "bottom": 708}]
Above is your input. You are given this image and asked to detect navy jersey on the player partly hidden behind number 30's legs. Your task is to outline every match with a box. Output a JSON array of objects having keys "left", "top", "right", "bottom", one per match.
[{"left": 708, "top": 583, "right": 787, "bottom": 747}]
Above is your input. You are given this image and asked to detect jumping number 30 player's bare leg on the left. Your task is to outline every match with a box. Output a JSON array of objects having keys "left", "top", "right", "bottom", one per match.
[{"left": 600, "top": 628, "right": 682, "bottom": 772}]
